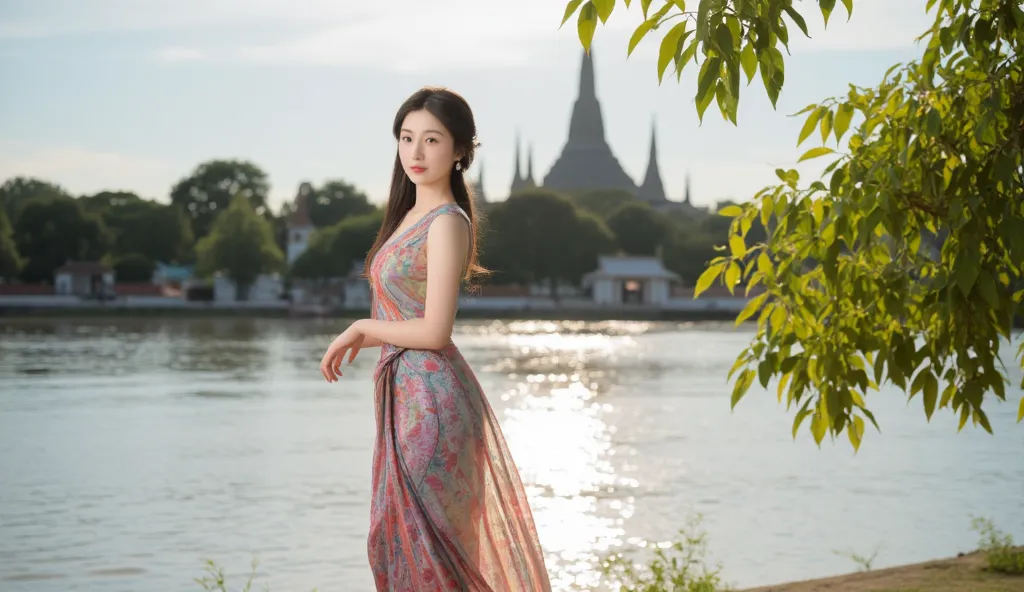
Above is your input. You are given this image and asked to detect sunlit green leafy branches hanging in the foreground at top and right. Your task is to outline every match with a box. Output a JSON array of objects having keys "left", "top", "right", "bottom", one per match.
[{"left": 563, "top": 0, "right": 1024, "bottom": 442}]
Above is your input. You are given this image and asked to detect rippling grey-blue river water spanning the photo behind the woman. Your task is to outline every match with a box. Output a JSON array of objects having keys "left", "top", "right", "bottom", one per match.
[{"left": 0, "top": 319, "right": 1024, "bottom": 592}]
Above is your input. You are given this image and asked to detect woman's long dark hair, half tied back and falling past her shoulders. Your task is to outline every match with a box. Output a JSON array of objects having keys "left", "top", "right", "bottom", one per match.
[{"left": 365, "top": 86, "right": 487, "bottom": 281}]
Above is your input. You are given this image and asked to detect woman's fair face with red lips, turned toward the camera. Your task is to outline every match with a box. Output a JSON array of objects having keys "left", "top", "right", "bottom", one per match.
[{"left": 398, "top": 110, "right": 461, "bottom": 185}]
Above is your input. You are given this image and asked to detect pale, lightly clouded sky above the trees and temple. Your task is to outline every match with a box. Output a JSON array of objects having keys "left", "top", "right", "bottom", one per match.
[{"left": 0, "top": 0, "right": 931, "bottom": 208}]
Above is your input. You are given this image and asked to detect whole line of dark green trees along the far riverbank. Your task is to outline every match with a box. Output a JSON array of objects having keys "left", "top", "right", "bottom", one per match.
[{"left": 0, "top": 160, "right": 763, "bottom": 297}]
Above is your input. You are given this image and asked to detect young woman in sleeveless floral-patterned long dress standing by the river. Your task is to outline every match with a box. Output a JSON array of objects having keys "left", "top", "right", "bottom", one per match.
[{"left": 321, "top": 88, "right": 551, "bottom": 592}]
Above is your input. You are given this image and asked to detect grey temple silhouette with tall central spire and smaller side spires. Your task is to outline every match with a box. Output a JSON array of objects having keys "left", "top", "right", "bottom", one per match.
[{"left": 497, "top": 48, "right": 693, "bottom": 209}]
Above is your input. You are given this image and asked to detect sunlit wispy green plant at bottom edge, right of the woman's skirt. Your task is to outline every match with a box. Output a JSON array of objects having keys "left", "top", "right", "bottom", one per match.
[{"left": 601, "top": 517, "right": 728, "bottom": 592}]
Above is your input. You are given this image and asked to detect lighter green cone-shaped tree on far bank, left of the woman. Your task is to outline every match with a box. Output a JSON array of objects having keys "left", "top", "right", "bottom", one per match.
[{"left": 196, "top": 194, "right": 285, "bottom": 300}]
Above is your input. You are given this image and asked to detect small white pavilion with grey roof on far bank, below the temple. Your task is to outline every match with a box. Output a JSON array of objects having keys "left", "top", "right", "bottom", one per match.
[{"left": 583, "top": 256, "right": 681, "bottom": 306}]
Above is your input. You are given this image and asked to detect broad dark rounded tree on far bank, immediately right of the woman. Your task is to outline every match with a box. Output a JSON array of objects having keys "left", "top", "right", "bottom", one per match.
[{"left": 483, "top": 189, "right": 614, "bottom": 297}]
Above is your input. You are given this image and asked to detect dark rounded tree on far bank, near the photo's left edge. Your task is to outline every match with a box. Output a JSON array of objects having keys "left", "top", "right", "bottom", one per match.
[{"left": 14, "top": 197, "right": 111, "bottom": 282}]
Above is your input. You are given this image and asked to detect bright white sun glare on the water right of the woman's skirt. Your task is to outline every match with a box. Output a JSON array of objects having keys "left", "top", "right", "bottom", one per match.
[{"left": 489, "top": 324, "right": 636, "bottom": 590}]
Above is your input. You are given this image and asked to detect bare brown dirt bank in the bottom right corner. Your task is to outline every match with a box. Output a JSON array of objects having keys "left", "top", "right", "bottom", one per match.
[{"left": 742, "top": 547, "right": 1024, "bottom": 592}]
